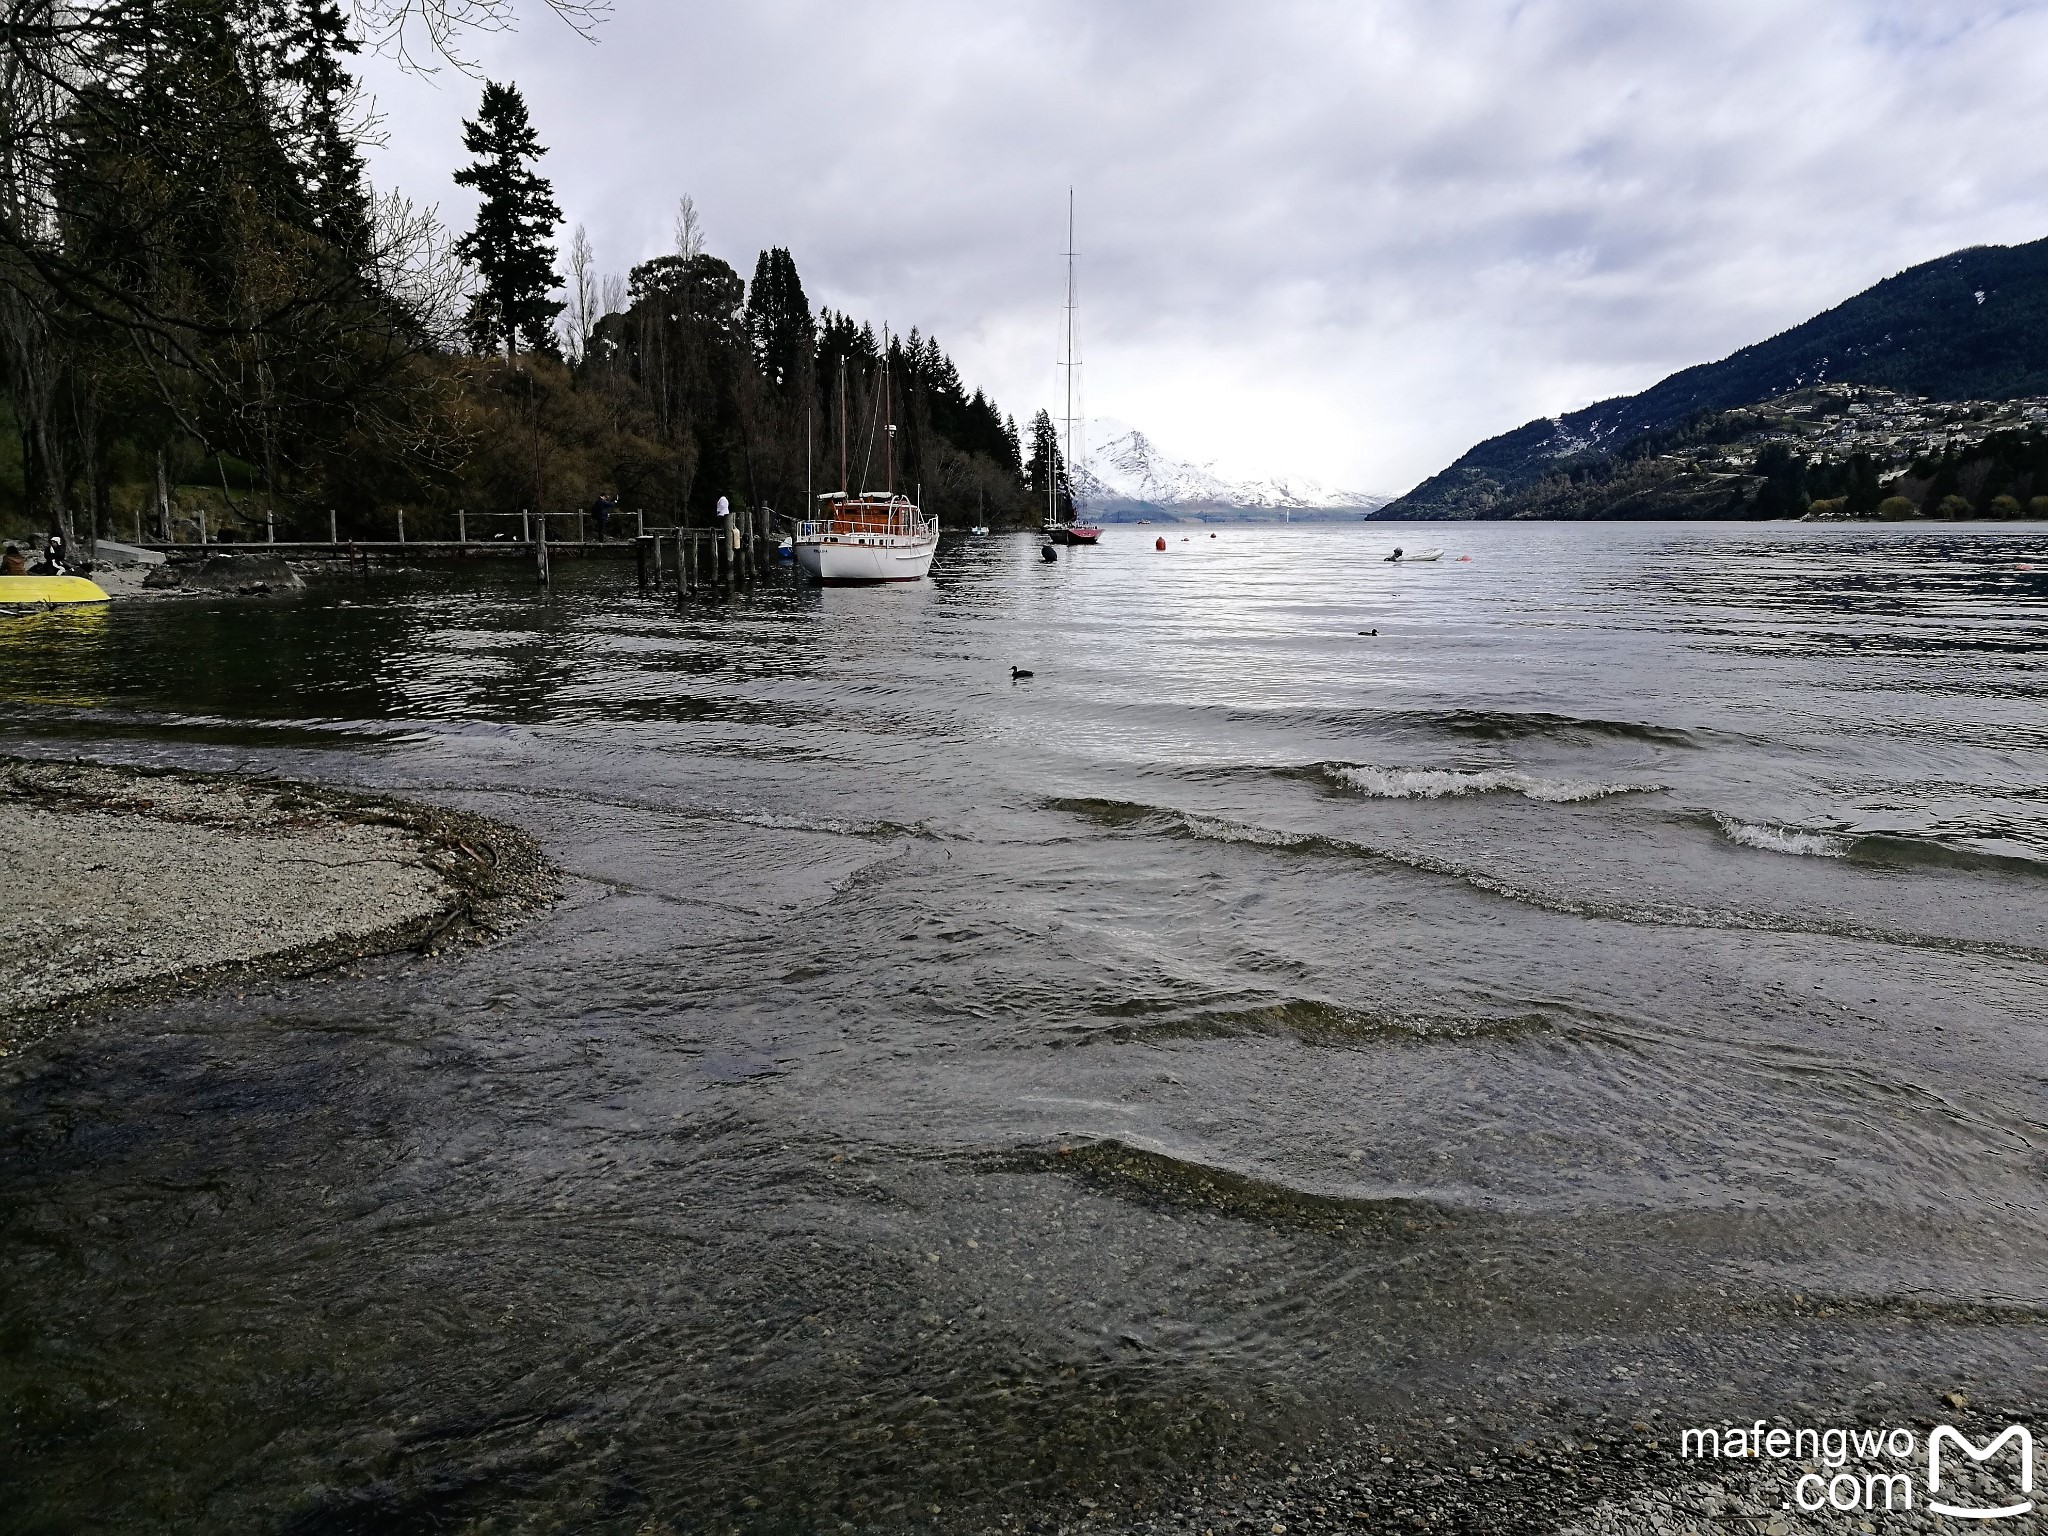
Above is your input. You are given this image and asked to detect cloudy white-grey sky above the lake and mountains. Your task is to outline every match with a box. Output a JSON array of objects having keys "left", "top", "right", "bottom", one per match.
[{"left": 362, "top": 0, "right": 2048, "bottom": 492}]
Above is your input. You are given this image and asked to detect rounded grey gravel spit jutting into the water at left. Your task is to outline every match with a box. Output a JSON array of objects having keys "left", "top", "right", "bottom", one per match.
[{"left": 0, "top": 758, "right": 559, "bottom": 1055}]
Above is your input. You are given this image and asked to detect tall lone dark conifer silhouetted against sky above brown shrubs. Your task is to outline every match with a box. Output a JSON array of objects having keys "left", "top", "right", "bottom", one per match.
[{"left": 455, "top": 82, "right": 563, "bottom": 354}]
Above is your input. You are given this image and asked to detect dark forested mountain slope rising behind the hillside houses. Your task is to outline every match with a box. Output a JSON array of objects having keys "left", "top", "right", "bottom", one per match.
[{"left": 1374, "top": 240, "right": 2048, "bottom": 518}]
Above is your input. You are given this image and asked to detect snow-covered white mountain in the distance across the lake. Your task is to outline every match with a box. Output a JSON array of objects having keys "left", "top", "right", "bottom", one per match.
[{"left": 1073, "top": 420, "right": 1389, "bottom": 522}]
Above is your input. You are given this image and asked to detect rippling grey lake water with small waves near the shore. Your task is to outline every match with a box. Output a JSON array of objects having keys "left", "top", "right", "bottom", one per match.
[{"left": 0, "top": 524, "right": 2048, "bottom": 1532}]
